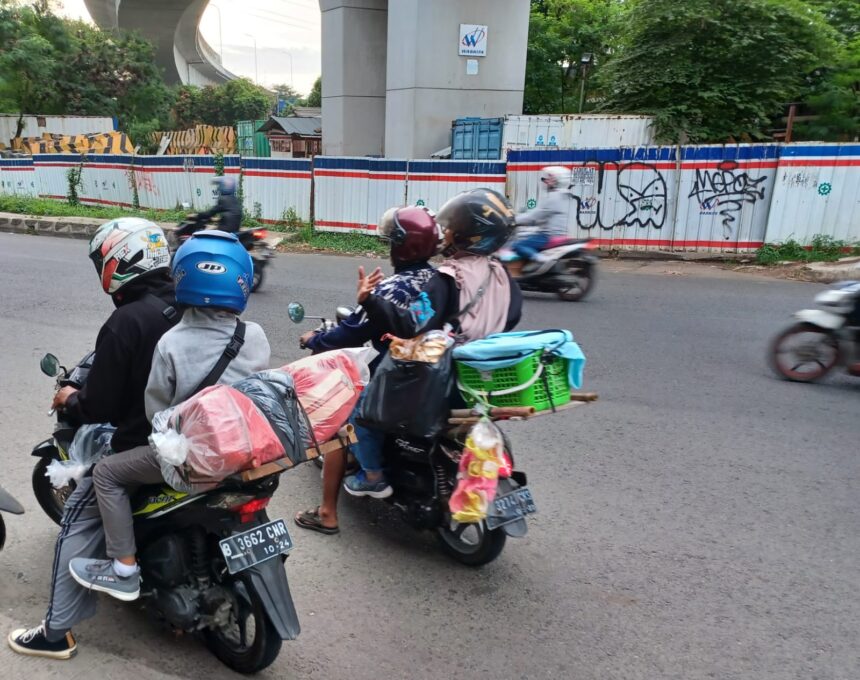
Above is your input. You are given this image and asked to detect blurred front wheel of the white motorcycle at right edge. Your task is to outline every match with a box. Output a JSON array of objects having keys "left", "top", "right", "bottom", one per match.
[{"left": 769, "top": 323, "right": 839, "bottom": 382}]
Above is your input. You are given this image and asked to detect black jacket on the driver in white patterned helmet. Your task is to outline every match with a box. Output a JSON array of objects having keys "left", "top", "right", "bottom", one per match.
[{"left": 65, "top": 278, "right": 181, "bottom": 451}]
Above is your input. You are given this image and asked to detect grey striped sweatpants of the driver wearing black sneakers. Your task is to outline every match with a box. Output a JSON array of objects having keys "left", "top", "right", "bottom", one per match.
[{"left": 45, "top": 477, "right": 105, "bottom": 641}]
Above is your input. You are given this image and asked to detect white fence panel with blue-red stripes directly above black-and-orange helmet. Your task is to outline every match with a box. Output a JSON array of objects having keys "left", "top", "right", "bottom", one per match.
[{"left": 406, "top": 160, "right": 507, "bottom": 210}]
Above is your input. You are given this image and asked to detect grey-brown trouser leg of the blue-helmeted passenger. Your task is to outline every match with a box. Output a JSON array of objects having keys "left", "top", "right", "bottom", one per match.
[{"left": 93, "top": 446, "right": 164, "bottom": 558}]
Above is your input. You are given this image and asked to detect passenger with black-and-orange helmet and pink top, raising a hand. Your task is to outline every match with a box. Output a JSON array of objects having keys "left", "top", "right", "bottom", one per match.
[{"left": 344, "top": 189, "right": 522, "bottom": 495}]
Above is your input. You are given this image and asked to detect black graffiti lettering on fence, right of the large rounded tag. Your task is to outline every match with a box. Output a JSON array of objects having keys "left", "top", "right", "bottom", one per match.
[{"left": 688, "top": 161, "right": 766, "bottom": 241}]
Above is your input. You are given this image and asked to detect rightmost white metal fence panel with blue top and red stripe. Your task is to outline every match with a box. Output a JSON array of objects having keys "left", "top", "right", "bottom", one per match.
[{"left": 766, "top": 143, "right": 860, "bottom": 245}]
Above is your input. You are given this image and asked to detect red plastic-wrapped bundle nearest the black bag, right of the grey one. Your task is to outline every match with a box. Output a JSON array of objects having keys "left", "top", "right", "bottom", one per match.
[{"left": 281, "top": 347, "right": 377, "bottom": 442}]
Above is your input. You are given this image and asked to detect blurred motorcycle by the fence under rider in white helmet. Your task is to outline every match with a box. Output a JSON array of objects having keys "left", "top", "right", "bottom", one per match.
[{"left": 499, "top": 236, "right": 598, "bottom": 302}]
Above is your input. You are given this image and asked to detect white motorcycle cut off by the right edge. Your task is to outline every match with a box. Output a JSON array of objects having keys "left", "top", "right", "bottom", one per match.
[{"left": 769, "top": 281, "right": 860, "bottom": 382}]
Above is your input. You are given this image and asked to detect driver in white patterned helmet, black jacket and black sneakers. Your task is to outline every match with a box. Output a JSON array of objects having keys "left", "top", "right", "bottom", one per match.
[{"left": 8, "top": 217, "right": 180, "bottom": 659}]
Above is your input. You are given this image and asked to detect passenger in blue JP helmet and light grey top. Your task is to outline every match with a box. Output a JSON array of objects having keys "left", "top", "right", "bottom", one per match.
[{"left": 69, "top": 230, "right": 270, "bottom": 600}]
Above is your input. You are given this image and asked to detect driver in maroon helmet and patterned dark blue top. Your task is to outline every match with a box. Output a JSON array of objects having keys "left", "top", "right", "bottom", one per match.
[{"left": 295, "top": 206, "right": 440, "bottom": 534}]
